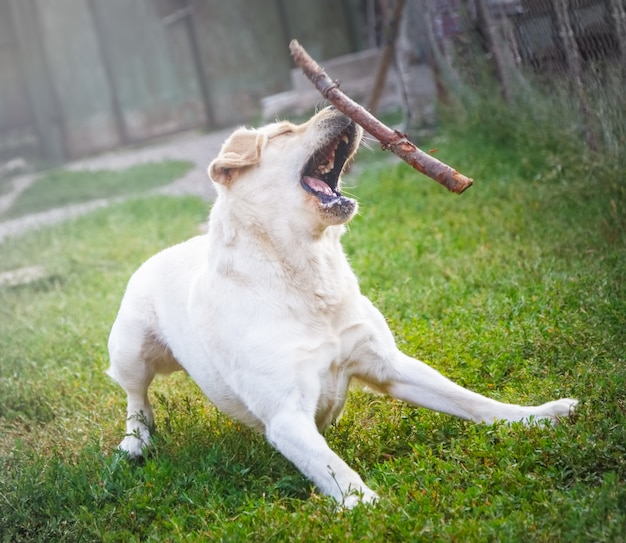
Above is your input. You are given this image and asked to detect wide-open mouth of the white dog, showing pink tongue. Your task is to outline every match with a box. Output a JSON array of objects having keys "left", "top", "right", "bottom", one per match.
[{"left": 300, "top": 116, "right": 360, "bottom": 204}]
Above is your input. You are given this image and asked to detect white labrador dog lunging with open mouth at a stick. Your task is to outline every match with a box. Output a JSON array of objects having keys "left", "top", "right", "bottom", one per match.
[{"left": 108, "top": 108, "right": 577, "bottom": 507}]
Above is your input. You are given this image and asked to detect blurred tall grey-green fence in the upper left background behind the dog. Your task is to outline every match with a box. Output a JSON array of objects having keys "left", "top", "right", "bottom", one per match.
[{"left": 0, "top": 0, "right": 362, "bottom": 163}]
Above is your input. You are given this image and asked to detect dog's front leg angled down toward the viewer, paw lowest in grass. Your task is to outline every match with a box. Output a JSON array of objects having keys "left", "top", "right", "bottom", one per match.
[{"left": 265, "top": 411, "right": 378, "bottom": 509}]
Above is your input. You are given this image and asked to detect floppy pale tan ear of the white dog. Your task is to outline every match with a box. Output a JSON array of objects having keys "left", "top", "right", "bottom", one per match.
[{"left": 208, "top": 128, "right": 267, "bottom": 185}]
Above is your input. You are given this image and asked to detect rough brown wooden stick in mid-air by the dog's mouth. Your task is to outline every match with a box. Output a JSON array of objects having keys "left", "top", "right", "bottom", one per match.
[{"left": 289, "top": 40, "right": 474, "bottom": 194}]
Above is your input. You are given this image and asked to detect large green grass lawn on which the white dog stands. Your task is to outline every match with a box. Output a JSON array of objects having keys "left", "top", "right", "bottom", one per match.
[{"left": 0, "top": 126, "right": 626, "bottom": 542}]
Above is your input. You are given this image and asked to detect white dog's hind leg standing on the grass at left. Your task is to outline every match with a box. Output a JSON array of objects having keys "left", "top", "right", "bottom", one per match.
[{"left": 107, "top": 317, "right": 156, "bottom": 457}]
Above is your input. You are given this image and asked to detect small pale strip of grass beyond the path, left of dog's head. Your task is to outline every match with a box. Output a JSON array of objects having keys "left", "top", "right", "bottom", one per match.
[{"left": 0, "top": 160, "right": 192, "bottom": 220}]
